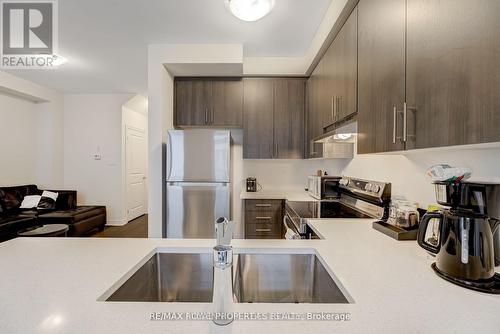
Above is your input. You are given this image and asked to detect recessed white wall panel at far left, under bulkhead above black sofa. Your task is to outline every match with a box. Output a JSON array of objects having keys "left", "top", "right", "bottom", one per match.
[{"left": 0, "top": 95, "right": 38, "bottom": 186}]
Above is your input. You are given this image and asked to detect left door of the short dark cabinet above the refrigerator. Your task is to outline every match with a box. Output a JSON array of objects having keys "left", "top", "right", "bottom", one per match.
[{"left": 175, "top": 79, "right": 212, "bottom": 126}]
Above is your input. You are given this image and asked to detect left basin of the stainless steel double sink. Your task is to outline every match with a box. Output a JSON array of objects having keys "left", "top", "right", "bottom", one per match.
[{"left": 106, "top": 253, "right": 213, "bottom": 303}]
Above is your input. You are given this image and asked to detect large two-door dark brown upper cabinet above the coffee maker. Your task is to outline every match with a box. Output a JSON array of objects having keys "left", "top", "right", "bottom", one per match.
[{"left": 358, "top": 0, "right": 500, "bottom": 153}]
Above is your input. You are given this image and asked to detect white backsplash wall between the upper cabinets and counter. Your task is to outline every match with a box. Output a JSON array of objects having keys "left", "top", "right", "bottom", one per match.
[{"left": 237, "top": 139, "right": 500, "bottom": 211}]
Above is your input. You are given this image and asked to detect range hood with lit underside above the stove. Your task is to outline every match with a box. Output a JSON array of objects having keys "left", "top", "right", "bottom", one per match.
[{"left": 314, "top": 122, "right": 358, "bottom": 159}]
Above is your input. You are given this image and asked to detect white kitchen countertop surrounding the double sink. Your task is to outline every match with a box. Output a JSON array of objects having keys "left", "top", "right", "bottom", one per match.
[{"left": 0, "top": 219, "right": 500, "bottom": 334}]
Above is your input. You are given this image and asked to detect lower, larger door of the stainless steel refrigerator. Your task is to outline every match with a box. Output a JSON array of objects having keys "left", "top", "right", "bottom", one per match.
[{"left": 166, "top": 182, "right": 231, "bottom": 239}]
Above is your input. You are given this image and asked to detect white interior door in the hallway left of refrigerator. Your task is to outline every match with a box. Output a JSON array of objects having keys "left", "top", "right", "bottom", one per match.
[{"left": 125, "top": 127, "right": 147, "bottom": 221}]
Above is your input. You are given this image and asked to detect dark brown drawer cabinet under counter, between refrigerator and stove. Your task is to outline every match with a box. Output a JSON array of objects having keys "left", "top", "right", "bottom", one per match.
[{"left": 245, "top": 200, "right": 283, "bottom": 239}]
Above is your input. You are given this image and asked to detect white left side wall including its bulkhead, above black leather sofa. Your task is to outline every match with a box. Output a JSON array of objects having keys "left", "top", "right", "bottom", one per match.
[{"left": 0, "top": 72, "right": 63, "bottom": 189}]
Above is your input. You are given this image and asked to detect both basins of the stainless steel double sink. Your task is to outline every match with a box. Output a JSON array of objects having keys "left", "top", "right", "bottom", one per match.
[{"left": 104, "top": 252, "right": 352, "bottom": 304}]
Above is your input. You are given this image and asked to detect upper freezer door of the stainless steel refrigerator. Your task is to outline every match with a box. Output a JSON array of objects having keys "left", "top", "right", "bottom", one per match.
[{"left": 167, "top": 129, "right": 231, "bottom": 182}]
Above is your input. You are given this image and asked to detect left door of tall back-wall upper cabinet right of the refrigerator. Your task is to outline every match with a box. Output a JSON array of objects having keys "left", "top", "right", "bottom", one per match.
[{"left": 243, "top": 78, "right": 274, "bottom": 159}]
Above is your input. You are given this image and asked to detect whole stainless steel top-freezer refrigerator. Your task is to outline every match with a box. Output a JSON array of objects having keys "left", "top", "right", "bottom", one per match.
[{"left": 164, "top": 129, "right": 231, "bottom": 238}]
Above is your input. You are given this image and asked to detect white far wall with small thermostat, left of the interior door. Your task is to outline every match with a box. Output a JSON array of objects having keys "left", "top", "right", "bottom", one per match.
[{"left": 64, "top": 94, "right": 133, "bottom": 225}]
